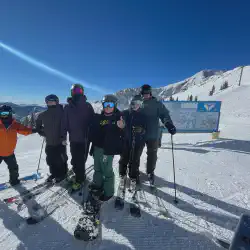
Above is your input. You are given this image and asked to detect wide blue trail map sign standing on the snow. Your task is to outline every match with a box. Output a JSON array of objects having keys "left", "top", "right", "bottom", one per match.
[{"left": 163, "top": 101, "right": 221, "bottom": 133}]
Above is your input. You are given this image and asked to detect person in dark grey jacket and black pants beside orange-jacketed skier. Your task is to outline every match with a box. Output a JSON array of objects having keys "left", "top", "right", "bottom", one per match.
[{"left": 36, "top": 94, "right": 68, "bottom": 182}]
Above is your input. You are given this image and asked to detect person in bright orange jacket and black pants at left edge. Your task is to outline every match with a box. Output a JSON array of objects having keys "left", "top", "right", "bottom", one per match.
[{"left": 0, "top": 105, "right": 36, "bottom": 186}]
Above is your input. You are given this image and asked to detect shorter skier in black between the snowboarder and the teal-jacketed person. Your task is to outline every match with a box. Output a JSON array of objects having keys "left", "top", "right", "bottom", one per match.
[{"left": 119, "top": 95, "right": 147, "bottom": 190}]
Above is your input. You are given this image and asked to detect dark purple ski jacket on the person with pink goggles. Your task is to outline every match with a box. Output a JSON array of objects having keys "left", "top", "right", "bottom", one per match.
[{"left": 61, "top": 96, "right": 94, "bottom": 143}]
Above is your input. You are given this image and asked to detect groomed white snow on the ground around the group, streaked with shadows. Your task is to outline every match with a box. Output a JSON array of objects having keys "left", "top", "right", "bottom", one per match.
[{"left": 0, "top": 69, "right": 250, "bottom": 250}]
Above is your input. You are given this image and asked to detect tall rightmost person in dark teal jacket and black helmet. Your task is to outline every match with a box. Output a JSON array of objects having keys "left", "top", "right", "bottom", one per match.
[{"left": 140, "top": 84, "right": 176, "bottom": 185}]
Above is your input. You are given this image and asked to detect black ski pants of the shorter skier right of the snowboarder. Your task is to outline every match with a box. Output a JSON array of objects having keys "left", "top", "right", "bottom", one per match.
[{"left": 119, "top": 144, "right": 144, "bottom": 180}]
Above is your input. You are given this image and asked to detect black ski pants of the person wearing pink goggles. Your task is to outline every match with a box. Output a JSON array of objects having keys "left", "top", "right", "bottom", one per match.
[{"left": 70, "top": 142, "right": 89, "bottom": 183}]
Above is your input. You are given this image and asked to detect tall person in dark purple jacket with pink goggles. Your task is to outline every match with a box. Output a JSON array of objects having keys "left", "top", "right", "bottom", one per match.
[{"left": 62, "top": 84, "right": 94, "bottom": 191}]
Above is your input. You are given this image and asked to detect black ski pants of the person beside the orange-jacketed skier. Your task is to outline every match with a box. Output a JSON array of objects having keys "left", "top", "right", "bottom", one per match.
[{"left": 45, "top": 144, "right": 68, "bottom": 178}]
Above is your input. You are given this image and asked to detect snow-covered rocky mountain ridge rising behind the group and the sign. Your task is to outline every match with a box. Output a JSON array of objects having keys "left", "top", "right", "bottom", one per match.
[{"left": 115, "top": 66, "right": 250, "bottom": 108}]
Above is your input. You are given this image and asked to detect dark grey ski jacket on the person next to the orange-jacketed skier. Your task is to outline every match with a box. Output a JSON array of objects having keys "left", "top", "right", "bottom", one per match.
[{"left": 36, "top": 104, "right": 66, "bottom": 146}]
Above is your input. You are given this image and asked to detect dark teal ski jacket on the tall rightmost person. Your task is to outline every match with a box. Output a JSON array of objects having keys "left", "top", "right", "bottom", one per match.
[{"left": 142, "top": 97, "right": 173, "bottom": 140}]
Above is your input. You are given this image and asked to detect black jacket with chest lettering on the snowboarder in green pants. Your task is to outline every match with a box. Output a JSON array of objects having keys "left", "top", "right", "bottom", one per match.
[{"left": 90, "top": 111, "right": 125, "bottom": 155}]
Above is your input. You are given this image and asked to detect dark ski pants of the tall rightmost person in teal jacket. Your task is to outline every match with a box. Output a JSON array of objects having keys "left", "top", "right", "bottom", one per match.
[{"left": 146, "top": 139, "right": 159, "bottom": 174}]
